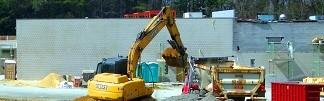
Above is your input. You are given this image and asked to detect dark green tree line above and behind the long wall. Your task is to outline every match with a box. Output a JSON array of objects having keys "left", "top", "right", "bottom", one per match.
[{"left": 0, "top": 0, "right": 324, "bottom": 35}]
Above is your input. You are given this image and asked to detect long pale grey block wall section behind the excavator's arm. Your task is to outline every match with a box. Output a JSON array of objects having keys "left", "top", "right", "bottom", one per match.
[{"left": 17, "top": 19, "right": 233, "bottom": 79}]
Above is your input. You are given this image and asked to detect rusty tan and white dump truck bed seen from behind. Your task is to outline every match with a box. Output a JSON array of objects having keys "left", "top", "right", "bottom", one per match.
[{"left": 213, "top": 67, "right": 264, "bottom": 96}]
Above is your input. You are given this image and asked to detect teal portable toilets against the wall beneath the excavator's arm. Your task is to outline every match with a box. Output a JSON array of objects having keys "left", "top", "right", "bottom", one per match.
[{"left": 136, "top": 62, "right": 159, "bottom": 82}]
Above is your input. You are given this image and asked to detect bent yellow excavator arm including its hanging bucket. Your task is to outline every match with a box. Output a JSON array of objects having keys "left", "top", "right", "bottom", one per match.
[{"left": 127, "top": 6, "right": 187, "bottom": 79}]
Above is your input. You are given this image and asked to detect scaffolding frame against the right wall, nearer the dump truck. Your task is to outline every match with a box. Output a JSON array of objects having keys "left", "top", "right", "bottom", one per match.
[{"left": 266, "top": 37, "right": 294, "bottom": 79}]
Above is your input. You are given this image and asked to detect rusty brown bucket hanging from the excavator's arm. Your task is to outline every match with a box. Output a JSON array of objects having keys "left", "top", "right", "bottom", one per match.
[{"left": 162, "top": 47, "right": 184, "bottom": 67}]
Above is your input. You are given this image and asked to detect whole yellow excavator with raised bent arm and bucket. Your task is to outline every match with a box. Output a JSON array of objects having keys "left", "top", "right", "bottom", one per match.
[{"left": 88, "top": 6, "right": 188, "bottom": 100}]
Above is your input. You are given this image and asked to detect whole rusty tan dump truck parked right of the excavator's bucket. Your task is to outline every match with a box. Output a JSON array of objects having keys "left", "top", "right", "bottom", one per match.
[{"left": 194, "top": 57, "right": 266, "bottom": 101}]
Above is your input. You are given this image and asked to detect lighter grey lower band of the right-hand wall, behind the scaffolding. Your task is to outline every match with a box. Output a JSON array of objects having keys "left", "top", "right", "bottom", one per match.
[{"left": 238, "top": 52, "right": 324, "bottom": 86}]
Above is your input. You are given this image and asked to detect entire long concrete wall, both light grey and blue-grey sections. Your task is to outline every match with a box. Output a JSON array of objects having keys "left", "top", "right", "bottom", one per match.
[{"left": 17, "top": 19, "right": 324, "bottom": 83}]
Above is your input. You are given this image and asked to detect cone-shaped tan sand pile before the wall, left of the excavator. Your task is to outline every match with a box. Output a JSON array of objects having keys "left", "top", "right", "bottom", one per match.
[{"left": 38, "top": 73, "right": 64, "bottom": 88}]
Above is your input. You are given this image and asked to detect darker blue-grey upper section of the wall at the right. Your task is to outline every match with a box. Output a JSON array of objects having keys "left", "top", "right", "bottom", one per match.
[{"left": 234, "top": 22, "right": 324, "bottom": 52}]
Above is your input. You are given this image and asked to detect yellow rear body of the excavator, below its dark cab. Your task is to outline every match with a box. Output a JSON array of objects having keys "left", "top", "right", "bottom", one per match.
[{"left": 88, "top": 73, "right": 153, "bottom": 101}]
